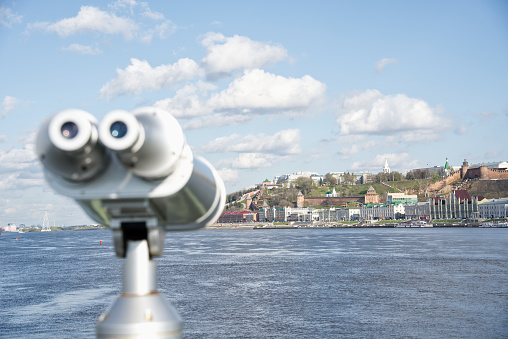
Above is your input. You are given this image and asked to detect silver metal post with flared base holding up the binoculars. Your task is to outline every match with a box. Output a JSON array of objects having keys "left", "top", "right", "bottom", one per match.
[{"left": 96, "top": 240, "right": 182, "bottom": 338}]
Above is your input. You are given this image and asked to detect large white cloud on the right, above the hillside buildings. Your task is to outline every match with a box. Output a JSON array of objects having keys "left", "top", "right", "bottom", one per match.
[{"left": 337, "top": 90, "right": 450, "bottom": 140}]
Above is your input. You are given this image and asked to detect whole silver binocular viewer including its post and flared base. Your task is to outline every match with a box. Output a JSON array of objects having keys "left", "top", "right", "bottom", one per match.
[{"left": 36, "top": 107, "right": 225, "bottom": 338}]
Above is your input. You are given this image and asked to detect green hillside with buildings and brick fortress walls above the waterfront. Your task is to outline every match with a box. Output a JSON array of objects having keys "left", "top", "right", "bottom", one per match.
[{"left": 226, "top": 159, "right": 508, "bottom": 210}]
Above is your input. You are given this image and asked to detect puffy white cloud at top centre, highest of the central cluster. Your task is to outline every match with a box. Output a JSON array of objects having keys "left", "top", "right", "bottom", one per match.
[{"left": 201, "top": 33, "right": 288, "bottom": 78}]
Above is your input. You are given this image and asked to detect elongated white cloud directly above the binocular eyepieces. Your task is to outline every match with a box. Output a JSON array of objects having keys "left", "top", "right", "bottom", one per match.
[{"left": 99, "top": 58, "right": 200, "bottom": 98}]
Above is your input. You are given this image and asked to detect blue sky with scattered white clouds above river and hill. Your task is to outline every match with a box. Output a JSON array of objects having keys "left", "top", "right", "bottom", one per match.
[{"left": 0, "top": 0, "right": 508, "bottom": 226}]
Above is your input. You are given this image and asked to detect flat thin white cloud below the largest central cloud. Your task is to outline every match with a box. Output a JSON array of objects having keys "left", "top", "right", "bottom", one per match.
[{"left": 202, "top": 129, "right": 301, "bottom": 155}]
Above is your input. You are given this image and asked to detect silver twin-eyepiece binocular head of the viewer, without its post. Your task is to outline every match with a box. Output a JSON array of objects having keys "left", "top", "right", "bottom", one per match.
[{"left": 36, "top": 107, "right": 225, "bottom": 239}]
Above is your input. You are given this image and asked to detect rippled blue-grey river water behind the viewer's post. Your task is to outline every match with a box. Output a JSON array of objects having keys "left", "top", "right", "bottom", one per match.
[{"left": 0, "top": 228, "right": 508, "bottom": 338}]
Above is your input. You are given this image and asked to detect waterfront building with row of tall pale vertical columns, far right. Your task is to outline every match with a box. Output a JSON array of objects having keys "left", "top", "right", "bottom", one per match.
[{"left": 429, "top": 190, "right": 478, "bottom": 220}]
